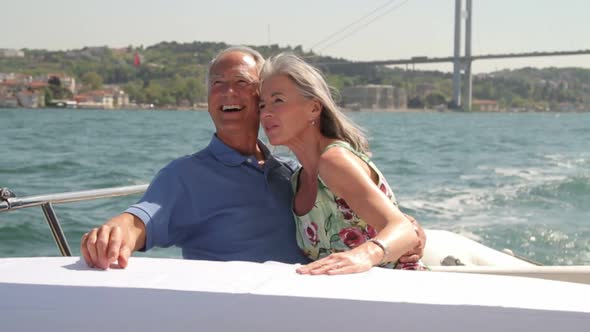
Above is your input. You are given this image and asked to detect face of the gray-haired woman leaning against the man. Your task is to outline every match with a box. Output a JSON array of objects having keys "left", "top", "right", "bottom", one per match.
[{"left": 259, "top": 75, "right": 317, "bottom": 145}]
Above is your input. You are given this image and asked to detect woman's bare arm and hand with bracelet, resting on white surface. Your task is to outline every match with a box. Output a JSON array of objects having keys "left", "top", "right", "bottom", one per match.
[{"left": 298, "top": 147, "right": 419, "bottom": 274}]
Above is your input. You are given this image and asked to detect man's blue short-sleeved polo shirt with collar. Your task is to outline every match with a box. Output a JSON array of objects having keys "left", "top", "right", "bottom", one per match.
[{"left": 126, "top": 135, "right": 309, "bottom": 263}]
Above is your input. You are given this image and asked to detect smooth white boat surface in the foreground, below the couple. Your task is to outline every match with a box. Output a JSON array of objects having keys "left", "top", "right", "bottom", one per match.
[{"left": 0, "top": 257, "right": 590, "bottom": 332}]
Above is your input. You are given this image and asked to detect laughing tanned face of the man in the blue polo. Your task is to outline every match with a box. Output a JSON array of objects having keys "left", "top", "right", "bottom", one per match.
[{"left": 208, "top": 51, "right": 259, "bottom": 139}]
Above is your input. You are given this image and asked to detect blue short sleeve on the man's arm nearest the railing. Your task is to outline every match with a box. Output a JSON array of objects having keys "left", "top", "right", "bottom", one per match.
[{"left": 125, "top": 167, "right": 184, "bottom": 251}]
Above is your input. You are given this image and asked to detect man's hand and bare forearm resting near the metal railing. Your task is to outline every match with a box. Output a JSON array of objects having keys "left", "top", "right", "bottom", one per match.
[{"left": 80, "top": 213, "right": 146, "bottom": 269}]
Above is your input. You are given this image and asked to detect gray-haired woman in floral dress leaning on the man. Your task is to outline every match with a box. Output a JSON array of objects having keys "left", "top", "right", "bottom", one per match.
[{"left": 260, "top": 54, "right": 423, "bottom": 274}]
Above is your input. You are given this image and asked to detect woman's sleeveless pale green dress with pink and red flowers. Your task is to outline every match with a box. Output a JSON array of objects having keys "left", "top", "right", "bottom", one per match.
[{"left": 291, "top": 141, "right": 425, "bottom": 270}]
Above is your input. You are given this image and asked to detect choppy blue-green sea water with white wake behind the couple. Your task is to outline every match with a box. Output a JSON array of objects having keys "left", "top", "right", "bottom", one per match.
[{"left": 0, "top": 109, "right": 590, "bottom": 265}]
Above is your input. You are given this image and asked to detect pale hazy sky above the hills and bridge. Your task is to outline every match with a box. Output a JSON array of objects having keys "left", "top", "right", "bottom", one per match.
[{"left": 0, "top": 0, "right": 590, "bottom": 73}]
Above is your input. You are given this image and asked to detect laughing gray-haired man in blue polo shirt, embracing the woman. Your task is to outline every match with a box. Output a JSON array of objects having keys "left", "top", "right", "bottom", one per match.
[{"left": 80, "top": 47, "right": 423, "bottom": 269}]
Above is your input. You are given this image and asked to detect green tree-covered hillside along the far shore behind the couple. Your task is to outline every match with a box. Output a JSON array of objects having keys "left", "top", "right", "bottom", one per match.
[{"left": 0, "top": 42, "right": 590, "bottom": 110}]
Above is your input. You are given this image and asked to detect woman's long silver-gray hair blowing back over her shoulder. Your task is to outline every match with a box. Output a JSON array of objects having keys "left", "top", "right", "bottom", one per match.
[{"left": 260, "top": 53, "right": 369, "bottom": 153}]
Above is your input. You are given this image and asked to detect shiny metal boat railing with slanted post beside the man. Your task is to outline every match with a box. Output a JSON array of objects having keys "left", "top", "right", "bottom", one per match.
[{"left": 0, "top": 184, "right": 148, "bottom": 256}]
